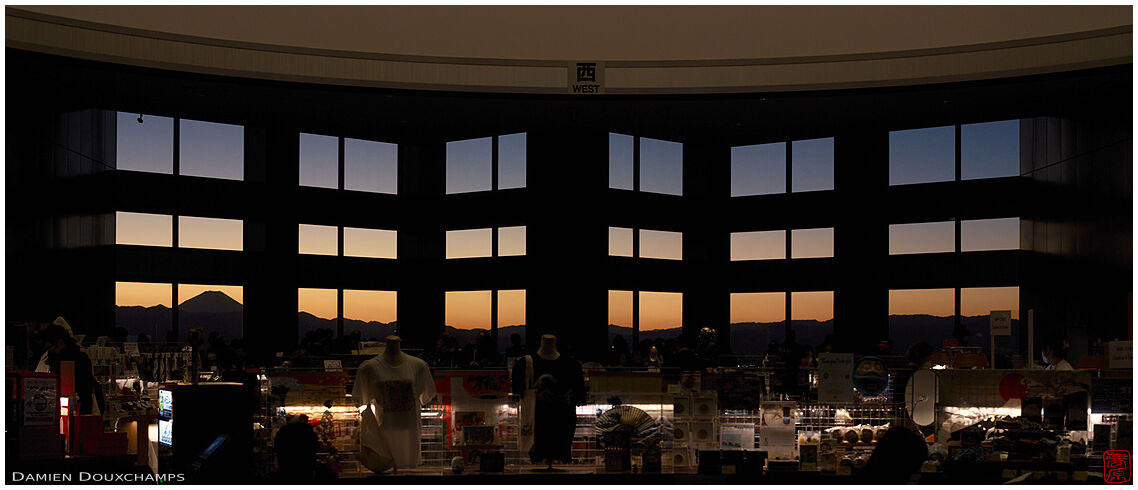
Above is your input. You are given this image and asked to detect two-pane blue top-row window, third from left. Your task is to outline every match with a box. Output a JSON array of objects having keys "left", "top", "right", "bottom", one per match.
[{"left": 446, "top": 133, "right": 526, "bottom": 194}]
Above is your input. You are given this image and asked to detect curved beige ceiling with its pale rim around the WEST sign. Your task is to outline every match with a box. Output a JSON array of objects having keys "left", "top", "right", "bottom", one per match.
[{"left": 6, "top": 6, "right": 1132, "bottom": 93}]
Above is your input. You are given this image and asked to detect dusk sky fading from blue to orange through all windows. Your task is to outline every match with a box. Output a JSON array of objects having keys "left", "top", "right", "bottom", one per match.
[{"left": 115, "top": 113, "right": 1020, "bottom": 330}]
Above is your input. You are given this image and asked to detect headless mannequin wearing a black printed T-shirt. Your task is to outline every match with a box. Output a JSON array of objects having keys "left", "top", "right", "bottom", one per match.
[{"left": 511, "top": 334, "right": 585, "bottom": 471}]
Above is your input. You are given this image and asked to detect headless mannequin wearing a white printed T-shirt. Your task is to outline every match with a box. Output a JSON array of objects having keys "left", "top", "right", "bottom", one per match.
[{"left": 352, "top": 335, "right": 436, "bottom": 473}]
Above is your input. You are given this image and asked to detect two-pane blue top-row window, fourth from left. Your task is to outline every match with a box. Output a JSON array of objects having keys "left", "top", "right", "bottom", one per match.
[{"left": 609, "top": 133, "right": 684, "bottom": 196}]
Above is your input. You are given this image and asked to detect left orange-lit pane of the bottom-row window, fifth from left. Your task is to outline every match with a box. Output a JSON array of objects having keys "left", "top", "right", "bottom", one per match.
[{"left": 731, "top": 292, "right": 786, "bottom": 355}]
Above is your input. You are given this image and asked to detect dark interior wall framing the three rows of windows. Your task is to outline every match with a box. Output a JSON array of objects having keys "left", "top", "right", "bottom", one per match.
[{"left": 6, "top": 49, "right": 1132, "bottom": 356}]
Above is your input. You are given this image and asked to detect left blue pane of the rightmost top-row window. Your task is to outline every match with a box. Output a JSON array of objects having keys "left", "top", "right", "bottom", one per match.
[{"left": 889, "top": 126, "right": 956, "bottom": 185}]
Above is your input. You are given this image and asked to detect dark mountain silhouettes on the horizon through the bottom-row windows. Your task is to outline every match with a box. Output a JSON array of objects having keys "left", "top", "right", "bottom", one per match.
[{"left": 115, "top": 291, "right": 1020, "bottom": 354}]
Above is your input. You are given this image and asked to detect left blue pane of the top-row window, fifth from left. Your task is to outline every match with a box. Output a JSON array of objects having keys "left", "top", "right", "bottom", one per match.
[{"left": 731, "top": 143, "right": 786, "bottom": 197}]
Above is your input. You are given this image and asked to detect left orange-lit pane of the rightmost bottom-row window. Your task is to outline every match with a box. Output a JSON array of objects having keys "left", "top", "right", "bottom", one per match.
[{"left": 877, "top": 289, "right": 956, "bottom": 354}]
